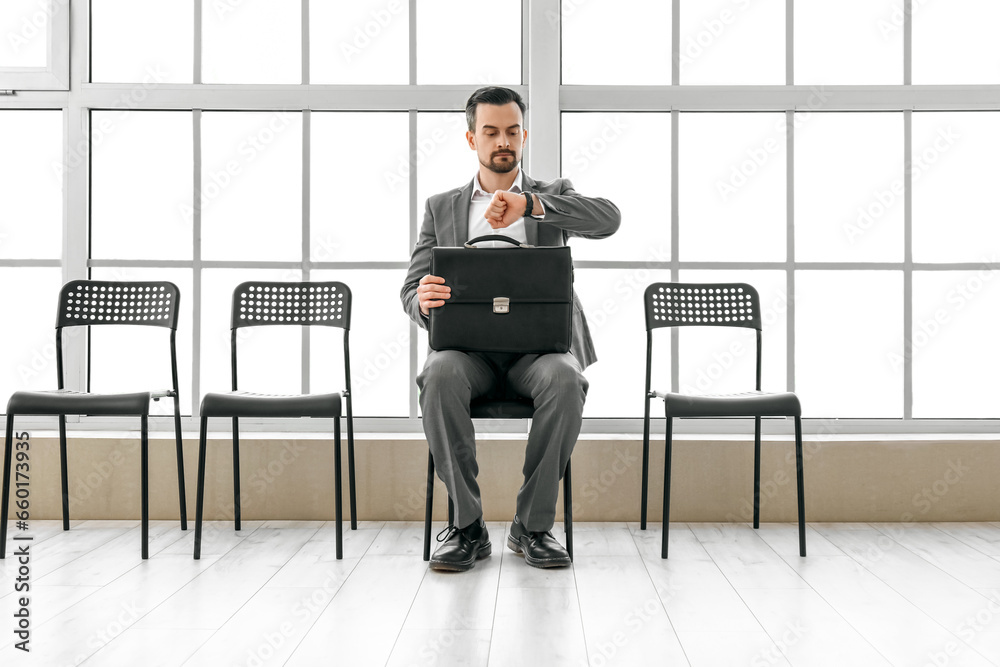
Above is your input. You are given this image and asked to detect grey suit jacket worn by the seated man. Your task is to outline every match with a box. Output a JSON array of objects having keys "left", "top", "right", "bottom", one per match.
[{"left": 399, "top": 174, "right": 621, "bottom": 368}]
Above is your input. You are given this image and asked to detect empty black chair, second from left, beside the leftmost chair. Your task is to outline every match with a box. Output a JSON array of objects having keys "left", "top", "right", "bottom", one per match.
[{"left": 194, "top": 281, "right": 357, "bottom": 559}]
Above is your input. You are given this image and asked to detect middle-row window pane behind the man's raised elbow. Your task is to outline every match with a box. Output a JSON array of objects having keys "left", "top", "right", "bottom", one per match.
[{"left": 564, "top": 113, "right": 670, "bottom": 262}]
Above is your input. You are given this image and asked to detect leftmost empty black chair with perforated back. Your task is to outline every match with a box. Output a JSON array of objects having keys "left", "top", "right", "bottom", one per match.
[{"left": 0, "top": 280, "right": 187, "bottom": 558}]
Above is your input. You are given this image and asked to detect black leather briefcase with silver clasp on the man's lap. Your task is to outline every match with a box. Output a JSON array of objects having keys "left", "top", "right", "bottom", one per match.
[{"left": 428, "top": 234, "right": 573, "bottom": 354}]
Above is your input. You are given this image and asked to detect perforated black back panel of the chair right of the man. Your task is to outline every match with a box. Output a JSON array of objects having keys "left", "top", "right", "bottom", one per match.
[{"left": 646, "top": 283, "right": 761, "bottom": 331}]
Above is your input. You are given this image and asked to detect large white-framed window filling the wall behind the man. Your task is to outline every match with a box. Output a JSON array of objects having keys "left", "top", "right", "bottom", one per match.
[{"left": 0, "top": 0, "right": 1000, "bottom": 432}]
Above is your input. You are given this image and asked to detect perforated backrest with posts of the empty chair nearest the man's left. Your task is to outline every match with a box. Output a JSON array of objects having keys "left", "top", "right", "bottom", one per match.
[{"left": 231, "top": 280, "right": 352, "bottom": 396}]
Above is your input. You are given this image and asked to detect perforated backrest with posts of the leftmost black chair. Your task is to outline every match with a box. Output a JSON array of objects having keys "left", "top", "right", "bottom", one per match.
[{"left": 56, "top": 280, "right": 181, "bottom": 394}]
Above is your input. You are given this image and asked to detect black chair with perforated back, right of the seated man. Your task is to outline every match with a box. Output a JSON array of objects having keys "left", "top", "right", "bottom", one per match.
[{"left": 640, "top": 283, "right": 806, "bottom": 558}]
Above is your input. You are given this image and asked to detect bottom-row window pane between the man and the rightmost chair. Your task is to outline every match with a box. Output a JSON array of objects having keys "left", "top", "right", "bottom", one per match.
[{"left": 574, "top": 267, "right": 670, "bottom": 417}]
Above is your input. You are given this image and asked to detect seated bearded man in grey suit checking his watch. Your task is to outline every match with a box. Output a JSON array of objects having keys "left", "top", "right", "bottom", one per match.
[{"left": 400, "top": 87, "right": 621, "bottom": 571}]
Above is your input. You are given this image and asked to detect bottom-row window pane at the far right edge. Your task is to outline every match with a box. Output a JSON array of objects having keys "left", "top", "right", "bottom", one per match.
[{"left": 916, "top": 272, "right": 1000, "bottom": 419}]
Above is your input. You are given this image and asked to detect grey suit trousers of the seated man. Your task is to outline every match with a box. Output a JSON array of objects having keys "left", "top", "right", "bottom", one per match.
[{"left": 417, "top": 350, "right": 588, "bottom": 532}]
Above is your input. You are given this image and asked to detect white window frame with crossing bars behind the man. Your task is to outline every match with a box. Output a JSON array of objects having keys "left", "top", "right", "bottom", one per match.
[{"left": 0, "top": 0, "right": 1000, "bottom": 437}]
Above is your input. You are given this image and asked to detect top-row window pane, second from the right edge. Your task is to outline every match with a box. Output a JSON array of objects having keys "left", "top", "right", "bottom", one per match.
[{"left": 795, "top": 0, "right": 903, "bottom": 85}]
